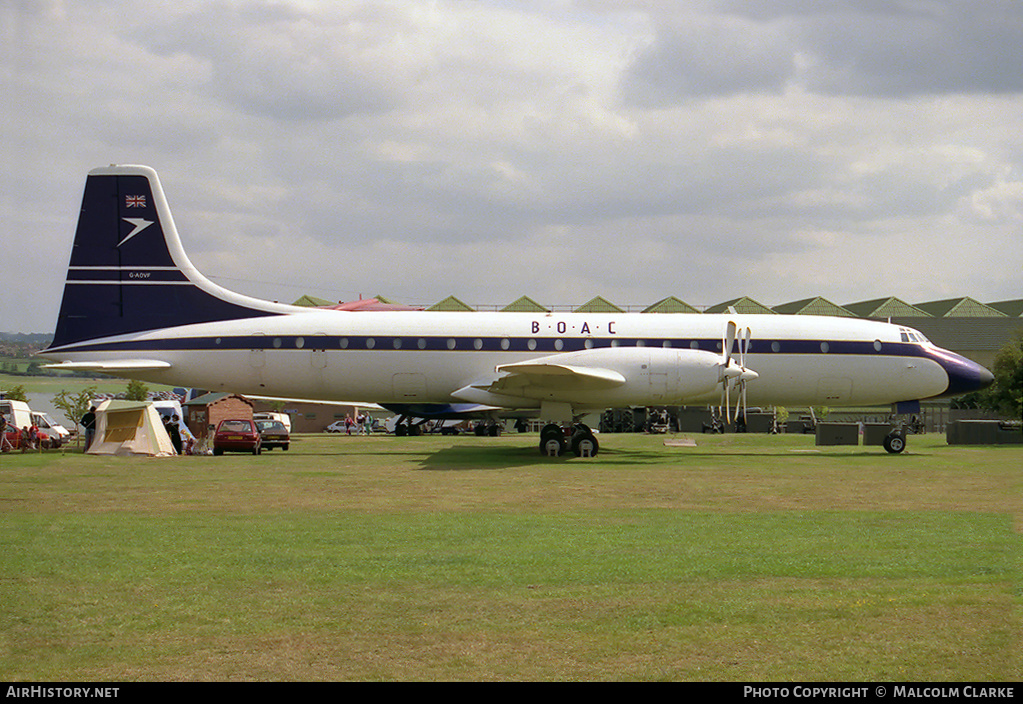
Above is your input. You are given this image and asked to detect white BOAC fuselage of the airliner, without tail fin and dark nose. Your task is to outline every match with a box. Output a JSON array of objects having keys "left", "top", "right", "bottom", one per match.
[{"left": 46, "top": 310, "right": 949, "bottom": 407}]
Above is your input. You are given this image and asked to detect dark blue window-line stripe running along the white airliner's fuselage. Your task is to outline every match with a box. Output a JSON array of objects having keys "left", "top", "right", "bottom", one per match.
[{"left": 46, "top": 335, "right": 929, "bottom": 357}]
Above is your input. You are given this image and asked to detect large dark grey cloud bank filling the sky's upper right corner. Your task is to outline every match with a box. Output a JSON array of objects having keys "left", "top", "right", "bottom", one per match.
[{"left": 623, "top": 0, "right": 1023, "bottom": 106}]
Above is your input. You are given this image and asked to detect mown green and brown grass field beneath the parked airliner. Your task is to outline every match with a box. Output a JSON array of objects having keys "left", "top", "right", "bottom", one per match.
[{"left": 0, "top": 434, "right": 1023, "bottom": 681}]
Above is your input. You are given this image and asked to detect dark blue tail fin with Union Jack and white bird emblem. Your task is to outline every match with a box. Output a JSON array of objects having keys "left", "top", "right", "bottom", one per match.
[{"left": 50, "top": 166, "right": 301, "bottom": 350}]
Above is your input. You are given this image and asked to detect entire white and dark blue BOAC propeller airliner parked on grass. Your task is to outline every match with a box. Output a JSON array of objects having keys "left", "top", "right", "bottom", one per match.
[{"left": 40, "top": 166, "right": 992, "bottom": 455}]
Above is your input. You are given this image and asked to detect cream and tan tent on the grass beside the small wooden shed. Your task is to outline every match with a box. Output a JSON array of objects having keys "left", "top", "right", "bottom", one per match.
[{"left": 88, "top": 401, "right": 175, "bottom": 457}]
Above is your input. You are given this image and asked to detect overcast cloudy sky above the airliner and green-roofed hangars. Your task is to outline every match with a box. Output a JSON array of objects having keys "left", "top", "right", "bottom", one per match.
[{"left": 0, "top": 0, "right": 1023, "bottom": 332}]
